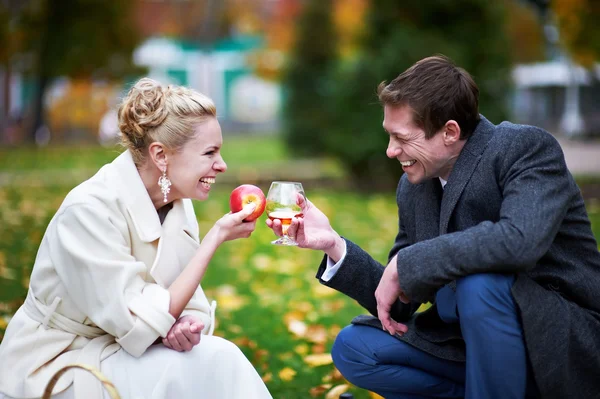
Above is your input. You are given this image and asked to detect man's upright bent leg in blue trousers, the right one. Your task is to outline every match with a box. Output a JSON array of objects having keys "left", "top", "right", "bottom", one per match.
[{"left": 456, "top": 273, "right": 535, "bottom": 399}]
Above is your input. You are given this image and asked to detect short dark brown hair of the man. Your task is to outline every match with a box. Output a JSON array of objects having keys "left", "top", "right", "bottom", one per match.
[{"left": 377, "top": 55, "right": 480, "bottom": 139}]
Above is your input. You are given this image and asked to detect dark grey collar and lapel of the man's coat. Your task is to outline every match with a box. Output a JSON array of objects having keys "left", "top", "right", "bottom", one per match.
[{"left": 440, "top": 116, "right": 495, "bottom": 235}]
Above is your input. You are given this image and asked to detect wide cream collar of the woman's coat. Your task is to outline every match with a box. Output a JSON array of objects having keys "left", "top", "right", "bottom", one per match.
[{"left": 109, "top": 150, "right": 198, "bottom": 242}]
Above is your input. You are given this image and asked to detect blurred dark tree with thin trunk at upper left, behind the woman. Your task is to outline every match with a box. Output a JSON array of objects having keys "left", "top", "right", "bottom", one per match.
[{"left": 19, "top": 0, "right": 138, "bottom": 143}]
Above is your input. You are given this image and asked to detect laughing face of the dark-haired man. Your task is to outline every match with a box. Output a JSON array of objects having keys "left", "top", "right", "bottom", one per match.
[{"left": 383, "top": 105, "right": 456, "bottom": 184}]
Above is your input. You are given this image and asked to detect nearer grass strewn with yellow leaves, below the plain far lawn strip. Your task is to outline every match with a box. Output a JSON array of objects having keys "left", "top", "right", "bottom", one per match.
[{"left": 0, "top": 185, "right": 396, "bottom": 398}]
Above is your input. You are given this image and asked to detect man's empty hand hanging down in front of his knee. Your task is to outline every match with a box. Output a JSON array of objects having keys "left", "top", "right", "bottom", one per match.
[{"left": 375, "top": 255, "right": 410, "bottom": 335}]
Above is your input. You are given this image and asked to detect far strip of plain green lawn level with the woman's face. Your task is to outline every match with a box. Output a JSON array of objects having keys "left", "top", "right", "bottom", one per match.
[{"left": 0, "top": 135, "right": 345, "bottom": 188}]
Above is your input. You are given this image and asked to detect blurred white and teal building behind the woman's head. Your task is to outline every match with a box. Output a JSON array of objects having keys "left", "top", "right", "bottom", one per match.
[{"left": 134, "top": 36, "right": 281, "bottom": 132}]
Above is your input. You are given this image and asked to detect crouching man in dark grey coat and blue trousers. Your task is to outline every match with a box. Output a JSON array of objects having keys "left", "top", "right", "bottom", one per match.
[{"left": 267, "top": 56, "right": 600, "bottom": 399}]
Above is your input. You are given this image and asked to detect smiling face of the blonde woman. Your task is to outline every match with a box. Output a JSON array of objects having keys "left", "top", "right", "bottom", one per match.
[{"left": 167, "top": 118, "right": 227, "bottom": 201}]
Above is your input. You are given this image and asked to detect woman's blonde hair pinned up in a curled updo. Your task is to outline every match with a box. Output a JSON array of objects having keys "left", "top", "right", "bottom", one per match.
[{"left": 119, "top": 78, "right": 216, "bottom": 167}]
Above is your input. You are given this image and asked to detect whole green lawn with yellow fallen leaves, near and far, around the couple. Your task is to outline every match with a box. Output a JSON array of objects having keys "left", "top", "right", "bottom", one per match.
[{"left": 0, "top": 136, "right": 600, "bottom": 398}]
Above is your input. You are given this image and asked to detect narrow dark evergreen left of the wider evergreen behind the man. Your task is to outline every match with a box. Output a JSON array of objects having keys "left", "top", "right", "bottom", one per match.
[{"left": 283, "top": 0, "right": 337, "bottom": 155}]
